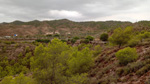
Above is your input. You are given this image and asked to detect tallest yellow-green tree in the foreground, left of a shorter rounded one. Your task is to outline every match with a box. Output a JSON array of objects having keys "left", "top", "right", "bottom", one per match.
[{"left": 31, "top": 39, "right": 69, "bottom": 84}]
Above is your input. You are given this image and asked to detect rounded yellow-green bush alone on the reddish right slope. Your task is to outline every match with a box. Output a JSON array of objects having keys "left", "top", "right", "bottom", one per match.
[{"left": 116, "top": 47, "right": 138, "bottom": 65}]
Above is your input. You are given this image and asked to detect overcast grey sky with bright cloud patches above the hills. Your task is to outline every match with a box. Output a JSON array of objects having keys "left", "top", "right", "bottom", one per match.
[{"left": 0, "top": 0, "right": 150, "bottom": 22}]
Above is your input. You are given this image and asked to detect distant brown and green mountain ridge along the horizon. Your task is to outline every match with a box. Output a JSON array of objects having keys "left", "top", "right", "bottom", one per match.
[{"left": 0, "top": 19, "right": 150, "bottom": 37}]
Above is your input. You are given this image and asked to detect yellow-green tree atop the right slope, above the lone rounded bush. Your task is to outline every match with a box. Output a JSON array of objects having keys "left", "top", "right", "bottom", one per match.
[{"left": 109, "top": 27, "right": 132, "bottom": 48}]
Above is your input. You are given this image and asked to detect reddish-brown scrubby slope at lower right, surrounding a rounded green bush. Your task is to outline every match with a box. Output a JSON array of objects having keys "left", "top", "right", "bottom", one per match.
[{"left": 89, "top": 43, "right": 150, "bottom": 84}]
